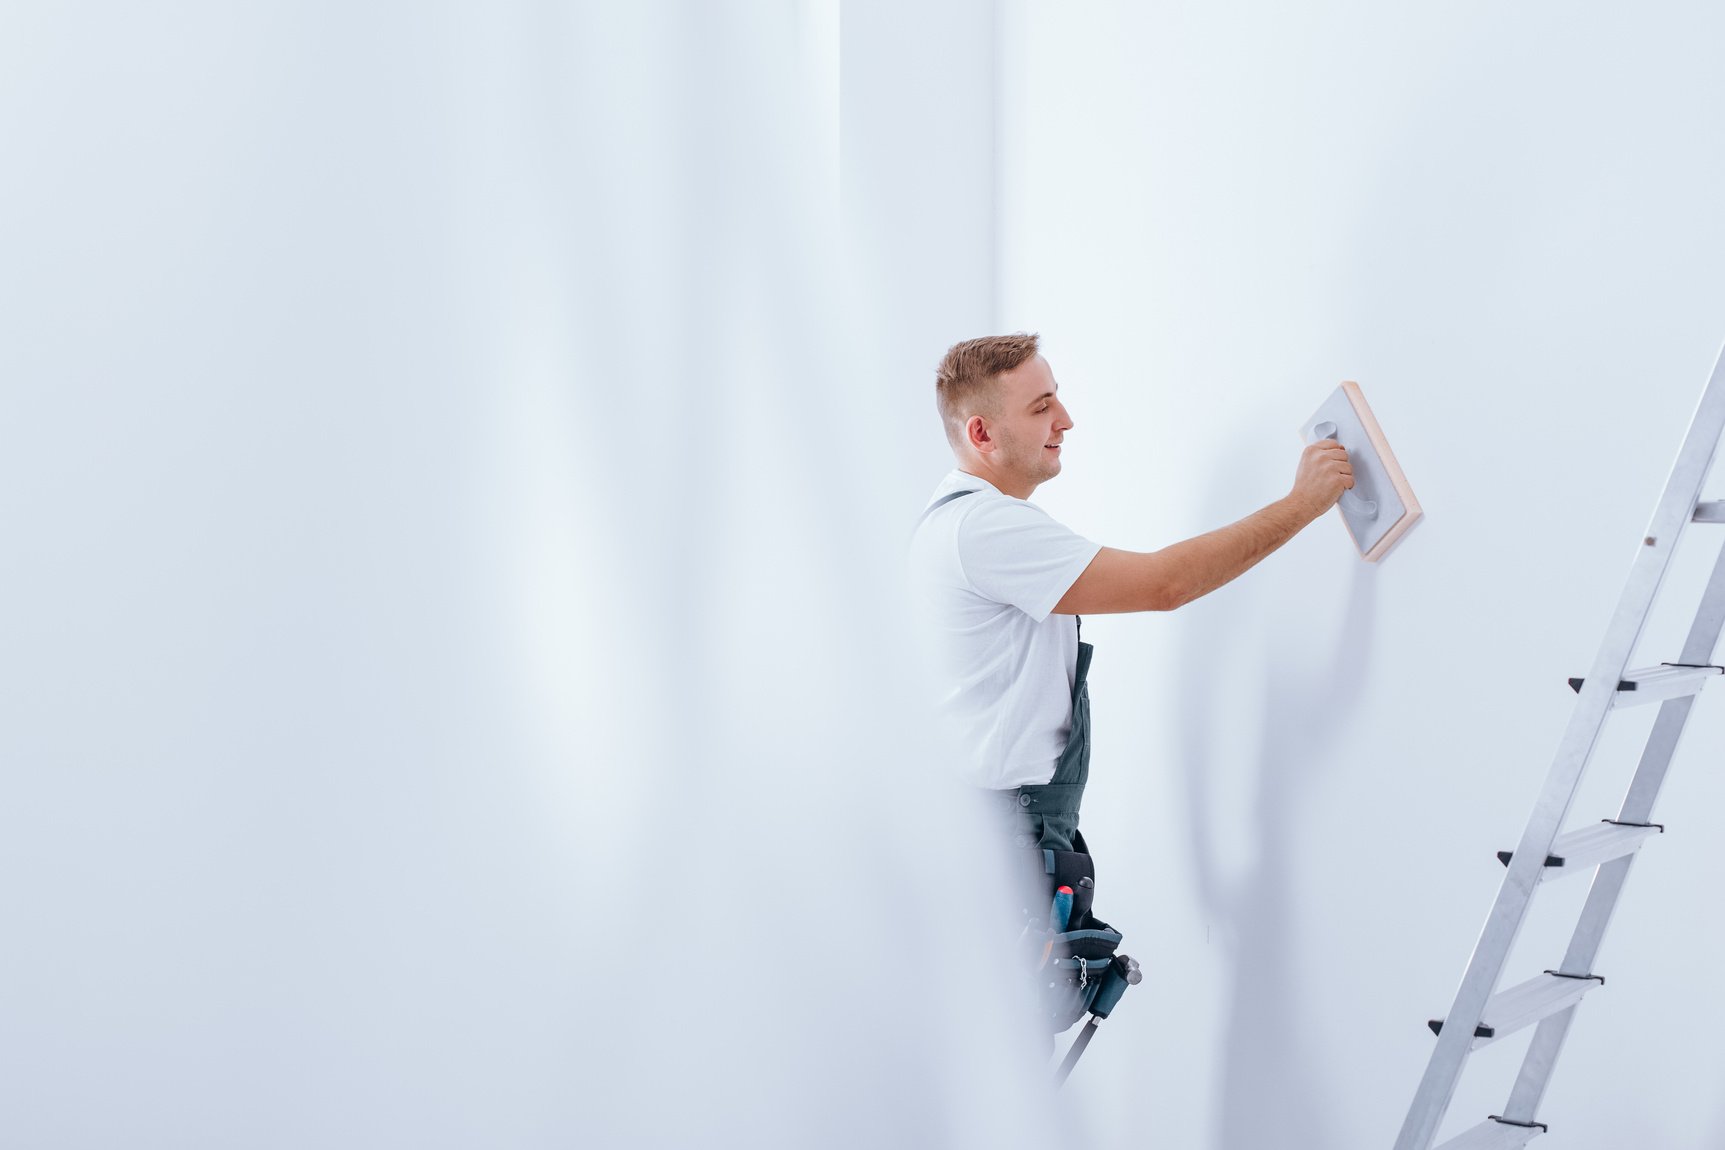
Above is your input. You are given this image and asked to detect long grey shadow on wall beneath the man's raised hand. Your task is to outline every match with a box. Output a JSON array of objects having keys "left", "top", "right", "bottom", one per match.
[{"left": 1178, "top": 493, "right": 1377, "bottom": 1150}]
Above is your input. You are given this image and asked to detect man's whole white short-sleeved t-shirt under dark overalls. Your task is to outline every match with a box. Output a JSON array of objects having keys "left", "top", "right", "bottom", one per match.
[{"left": 911, "top": 471, "right": 1102, "bottom": 790}]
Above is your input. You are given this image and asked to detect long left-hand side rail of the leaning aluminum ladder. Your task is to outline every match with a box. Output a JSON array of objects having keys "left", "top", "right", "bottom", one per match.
[{"left": 1396, "top": 348, "right": 1725, "bottom": 1150}]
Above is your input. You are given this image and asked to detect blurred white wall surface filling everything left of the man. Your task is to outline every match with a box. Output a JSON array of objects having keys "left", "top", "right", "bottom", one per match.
[{"left": 0, "top": 2, "right": 1052, "bottom": 1150}]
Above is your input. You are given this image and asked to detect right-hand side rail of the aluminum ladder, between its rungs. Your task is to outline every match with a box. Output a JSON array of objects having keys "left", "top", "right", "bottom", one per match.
[{"left": 1504, "top": 547, "right": 1725, "bottom": 1122}]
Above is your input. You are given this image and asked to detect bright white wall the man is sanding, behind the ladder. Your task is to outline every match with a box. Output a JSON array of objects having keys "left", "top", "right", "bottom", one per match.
[{"left": 999, "top": 0, "right": 1725, "bottom": 1150}]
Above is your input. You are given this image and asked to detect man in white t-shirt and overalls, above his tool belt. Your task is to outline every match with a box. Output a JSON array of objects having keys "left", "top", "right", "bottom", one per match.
[{"left": 911, "top": 333, "right": 1354, "bottom": 868}]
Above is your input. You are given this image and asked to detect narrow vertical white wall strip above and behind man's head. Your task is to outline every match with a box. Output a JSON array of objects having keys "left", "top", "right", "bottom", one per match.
[{"left": 838, "top": 0, "right": 1002, "bottom": 506}]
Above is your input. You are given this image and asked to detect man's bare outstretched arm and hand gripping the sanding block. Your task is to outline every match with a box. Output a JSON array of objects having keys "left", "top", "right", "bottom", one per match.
[{"left": 1054, "top": 440, "right": 1354, "bottom": 616}]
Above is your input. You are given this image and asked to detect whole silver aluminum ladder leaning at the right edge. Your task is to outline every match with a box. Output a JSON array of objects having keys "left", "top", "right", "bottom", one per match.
[{"left": 1396, "top": 350, "right": 1725, "bottom": 1150}]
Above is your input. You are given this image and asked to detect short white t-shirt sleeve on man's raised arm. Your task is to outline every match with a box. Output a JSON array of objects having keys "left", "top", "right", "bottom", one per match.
[{"left": 957, "top": 498, "right": 1102, "bottom": 622}]
